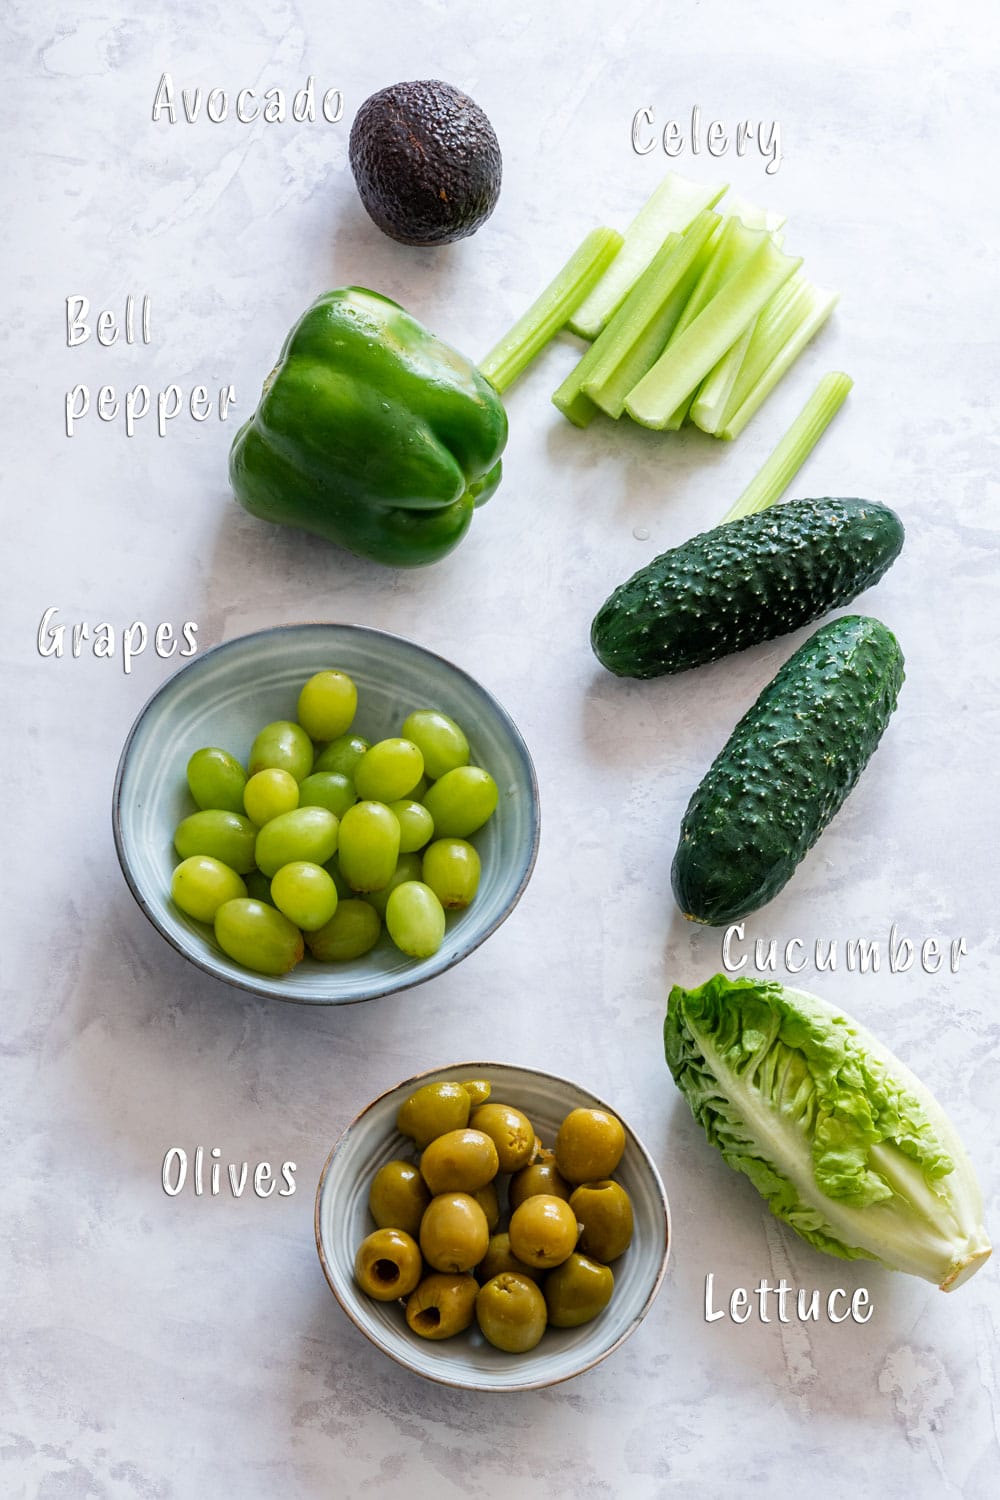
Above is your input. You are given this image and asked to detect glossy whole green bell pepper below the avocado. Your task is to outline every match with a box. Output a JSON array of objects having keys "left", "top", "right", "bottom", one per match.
[{"left": 229, "top": 287, "right": 507, "bottom": 567}]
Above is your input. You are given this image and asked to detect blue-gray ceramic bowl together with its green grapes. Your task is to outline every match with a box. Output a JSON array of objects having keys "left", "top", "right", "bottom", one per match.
[{"left": 112, "top": 624, "right": 538, "bottom": 1005}]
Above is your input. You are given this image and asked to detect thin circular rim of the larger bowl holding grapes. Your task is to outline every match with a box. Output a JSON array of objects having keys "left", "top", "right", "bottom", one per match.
[{"left": 111, "top": 620, "right": 541, "bottom": 1007}]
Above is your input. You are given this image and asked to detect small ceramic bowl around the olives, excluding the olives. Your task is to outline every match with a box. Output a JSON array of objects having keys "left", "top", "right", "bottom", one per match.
[{"left": 315, "top": 1062, "right": 670, "bottom": 1391}]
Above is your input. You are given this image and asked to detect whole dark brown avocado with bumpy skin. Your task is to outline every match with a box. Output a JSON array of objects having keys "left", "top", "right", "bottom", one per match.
[{"left": 349, "top": 78, "right": 501, "bottom": 245}]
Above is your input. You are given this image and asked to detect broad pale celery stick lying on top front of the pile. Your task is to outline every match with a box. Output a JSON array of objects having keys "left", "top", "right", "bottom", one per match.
[{"left": 625, "top": 234, "right": 802, "bottom": 429}]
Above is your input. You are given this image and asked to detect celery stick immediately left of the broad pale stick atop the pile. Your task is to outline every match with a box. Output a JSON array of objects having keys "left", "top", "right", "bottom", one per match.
[{"left": 580, "top": 209, "right": 718, "bottom": 417}]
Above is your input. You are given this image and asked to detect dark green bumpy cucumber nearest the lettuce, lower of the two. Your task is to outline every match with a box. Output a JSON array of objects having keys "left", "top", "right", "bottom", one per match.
[{"left": 670, "top": 615, "right": 904, "bottom": 926}]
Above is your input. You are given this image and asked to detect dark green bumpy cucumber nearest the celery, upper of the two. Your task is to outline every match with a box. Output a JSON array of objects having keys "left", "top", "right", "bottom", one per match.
[{"left": 591, "top": 498, "right": 904, "bottom": 678}]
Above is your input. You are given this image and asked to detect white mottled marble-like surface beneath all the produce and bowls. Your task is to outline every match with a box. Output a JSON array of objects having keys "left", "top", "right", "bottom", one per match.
[{"left": 0, "top": 0, "right": 1000, "bottom": 1500}]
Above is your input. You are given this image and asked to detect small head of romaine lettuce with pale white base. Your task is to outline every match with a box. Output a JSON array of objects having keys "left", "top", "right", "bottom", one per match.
[{"left": 664, "top": 974, "right": 991, "bottom": 1292}]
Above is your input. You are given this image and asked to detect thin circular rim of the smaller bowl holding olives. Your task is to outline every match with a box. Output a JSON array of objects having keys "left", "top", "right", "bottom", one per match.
[{"left": 313, "top": 1059, "right": 673, "bottom": 1395}]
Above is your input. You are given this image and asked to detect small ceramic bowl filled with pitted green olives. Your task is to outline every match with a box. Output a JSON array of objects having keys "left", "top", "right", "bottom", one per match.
[{"left": 315, "top": 1062, "right": 670, "bottom": 1391}]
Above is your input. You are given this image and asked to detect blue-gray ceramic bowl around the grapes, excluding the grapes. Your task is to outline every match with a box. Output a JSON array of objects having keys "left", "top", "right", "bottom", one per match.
[{"left": 112, "top": 624, "right": 538, "bottom": 1005}]
